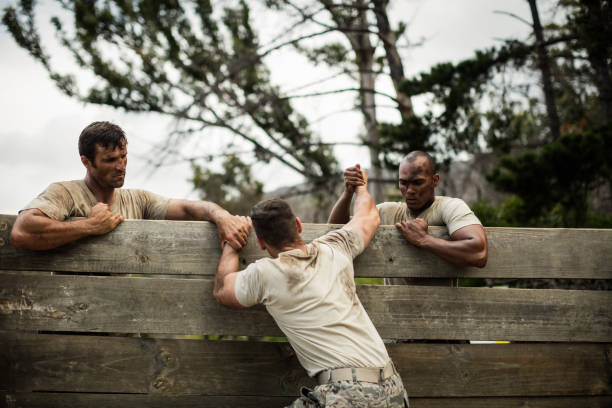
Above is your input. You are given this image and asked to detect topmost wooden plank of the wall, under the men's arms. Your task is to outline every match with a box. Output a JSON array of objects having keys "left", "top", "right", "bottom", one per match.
[{"left": 0, "top": 215, "right": 612, "bottom": 279}]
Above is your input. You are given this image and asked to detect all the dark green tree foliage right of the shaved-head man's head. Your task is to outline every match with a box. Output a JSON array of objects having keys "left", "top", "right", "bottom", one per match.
[{"left": 379, "top": 0, "right": 612, "bottom": 227}]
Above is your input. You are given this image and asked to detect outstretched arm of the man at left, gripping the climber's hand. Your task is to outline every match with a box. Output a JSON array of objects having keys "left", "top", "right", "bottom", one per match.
[{"left": 166, "top": 200, "right": 249, "bottom": 250}]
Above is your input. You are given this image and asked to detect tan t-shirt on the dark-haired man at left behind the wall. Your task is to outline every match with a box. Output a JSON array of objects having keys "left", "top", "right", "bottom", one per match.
[{"left": 21, "top": 180, "right": 170, "bottom": 221}]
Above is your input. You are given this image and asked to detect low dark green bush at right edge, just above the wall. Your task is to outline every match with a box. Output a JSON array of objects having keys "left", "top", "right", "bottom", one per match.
[{"left": 488, "top": 127, "right": 612, "bottom": 227}]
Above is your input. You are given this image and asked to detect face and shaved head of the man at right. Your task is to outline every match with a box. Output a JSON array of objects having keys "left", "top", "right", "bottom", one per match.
[{"left": 399, "top": 157, "right": 439, "bottom": 214}]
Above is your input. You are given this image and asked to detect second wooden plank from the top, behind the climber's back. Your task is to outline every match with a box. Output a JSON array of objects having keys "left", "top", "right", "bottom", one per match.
[{"left": 0, "top": 272, "right": 612, "bottom": 342}]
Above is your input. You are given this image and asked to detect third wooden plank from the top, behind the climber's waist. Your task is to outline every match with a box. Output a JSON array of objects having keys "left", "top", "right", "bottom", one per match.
[{"left": 0, "top": 333, "right": 612, "bottom": 398}]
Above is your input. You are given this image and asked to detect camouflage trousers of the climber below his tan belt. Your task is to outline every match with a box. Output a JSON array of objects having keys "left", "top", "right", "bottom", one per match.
[{"left": 285, "top": 374, "right": 408, "bottom": 408}]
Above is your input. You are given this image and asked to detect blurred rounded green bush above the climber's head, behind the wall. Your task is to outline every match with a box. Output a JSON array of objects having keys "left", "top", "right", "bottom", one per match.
[{"left": 191, "top": 155, "right": 263, "bottom": 215}]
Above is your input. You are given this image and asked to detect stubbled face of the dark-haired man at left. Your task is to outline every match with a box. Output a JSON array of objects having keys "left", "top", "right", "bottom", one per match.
[{"left": 85, "top": 143, "right": 127, "bottom": 188}]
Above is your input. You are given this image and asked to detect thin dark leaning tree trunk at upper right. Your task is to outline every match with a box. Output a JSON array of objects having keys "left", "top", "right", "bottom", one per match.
[{"left": 528, "top": 0, "right": 561, "bottom": 140}]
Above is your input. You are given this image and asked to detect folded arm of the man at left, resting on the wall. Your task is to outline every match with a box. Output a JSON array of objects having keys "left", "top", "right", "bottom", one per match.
[{"left": 11, "top": 203, "right": 124, "bottom": 250}]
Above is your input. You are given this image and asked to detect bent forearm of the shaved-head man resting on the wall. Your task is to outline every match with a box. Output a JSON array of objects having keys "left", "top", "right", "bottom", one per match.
[{"left": 395, "top": 218, "right": 488, "bottom": 268}]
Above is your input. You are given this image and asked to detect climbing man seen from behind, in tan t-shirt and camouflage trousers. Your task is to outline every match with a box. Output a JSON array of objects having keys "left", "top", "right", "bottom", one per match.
[{"left": 213, "top": 174, "right": 408, "bottom": 408}]
